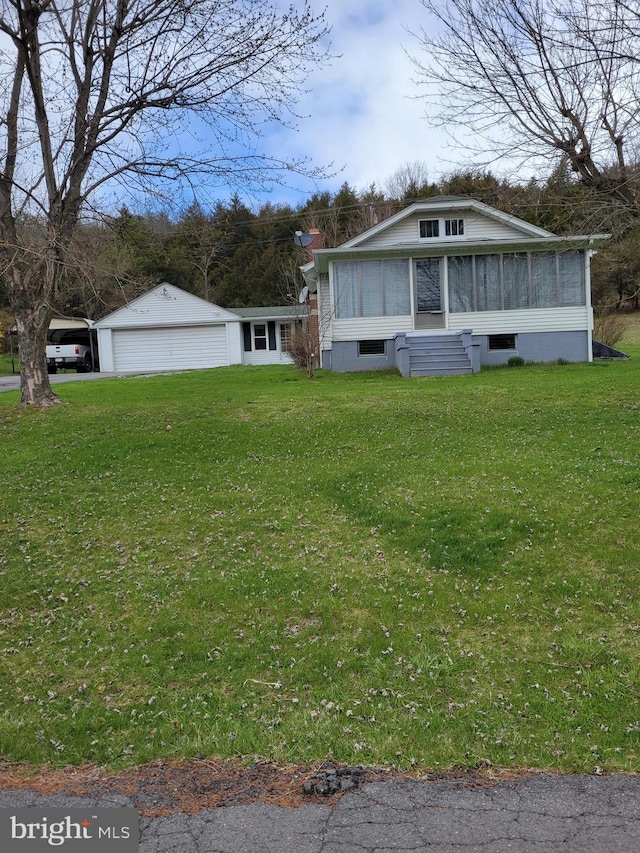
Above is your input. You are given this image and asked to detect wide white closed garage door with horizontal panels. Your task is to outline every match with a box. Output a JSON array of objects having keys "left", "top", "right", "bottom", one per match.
[{"left": 113, "top": 323, "right": 229, "bottom": 370}]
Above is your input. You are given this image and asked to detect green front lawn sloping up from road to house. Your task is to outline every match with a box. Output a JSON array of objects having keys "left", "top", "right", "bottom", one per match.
[{"left": 0, "top": 345, "right": 640, "bottom": 772}]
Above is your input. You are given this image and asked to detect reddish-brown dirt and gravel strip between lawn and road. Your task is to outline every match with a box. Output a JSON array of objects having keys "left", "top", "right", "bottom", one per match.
[{"left": 0, "top": 759, "right": 536, "bottom": 817}]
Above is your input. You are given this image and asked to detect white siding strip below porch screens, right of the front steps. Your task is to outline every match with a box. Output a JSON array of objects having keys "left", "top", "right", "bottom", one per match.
[{"left": 447, "top": 306, "right": 592, "bottom": 335}]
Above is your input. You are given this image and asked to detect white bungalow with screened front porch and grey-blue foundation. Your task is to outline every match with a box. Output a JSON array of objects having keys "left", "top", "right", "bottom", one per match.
[{"left": 303, "top": 196, "right": 608, "bottom": 376}]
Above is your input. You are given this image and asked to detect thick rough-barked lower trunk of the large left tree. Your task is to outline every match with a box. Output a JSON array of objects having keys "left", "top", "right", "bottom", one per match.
[{"left": 10, "top": 279, "right": 59, "bottom": 408}]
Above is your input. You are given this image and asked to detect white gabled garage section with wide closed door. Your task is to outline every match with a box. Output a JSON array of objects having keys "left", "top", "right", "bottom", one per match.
[{"left": 95, "top": 283, "right": 242, "bottom": 373}]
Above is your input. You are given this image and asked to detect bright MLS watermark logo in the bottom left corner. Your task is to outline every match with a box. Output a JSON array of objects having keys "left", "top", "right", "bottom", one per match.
[{"left": 0, "top": 808, "right": 138, "bottom": 853}]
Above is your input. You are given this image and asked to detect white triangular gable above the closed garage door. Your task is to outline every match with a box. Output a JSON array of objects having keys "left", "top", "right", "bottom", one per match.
[{"left": 95, "top": 282, "right": 240, "bottom": 329}]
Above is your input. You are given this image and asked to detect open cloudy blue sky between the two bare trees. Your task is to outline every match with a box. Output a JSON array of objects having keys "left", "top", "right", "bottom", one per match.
[{"left": 240, "top": 0, "right": 456, "bottom": 204}]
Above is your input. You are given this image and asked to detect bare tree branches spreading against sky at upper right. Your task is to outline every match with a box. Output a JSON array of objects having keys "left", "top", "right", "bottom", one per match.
[{"left": 414, "top": 0, "right": 640, "bottom": 215}]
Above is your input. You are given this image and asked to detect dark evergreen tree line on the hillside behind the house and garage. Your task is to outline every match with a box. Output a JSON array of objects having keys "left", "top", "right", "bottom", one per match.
[{"left": 0, "top": 164, "right": 640, "bottom": 319}]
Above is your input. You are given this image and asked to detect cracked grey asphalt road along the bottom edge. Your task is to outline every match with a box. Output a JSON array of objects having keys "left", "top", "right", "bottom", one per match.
[{"left": 0, "top": 776, "right": 640, "bottom": 853}]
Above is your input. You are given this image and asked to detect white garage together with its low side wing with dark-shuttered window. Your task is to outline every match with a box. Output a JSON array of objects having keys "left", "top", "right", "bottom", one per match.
[{"left": 95, "top": 282, "right": 299, "bottom": 373}]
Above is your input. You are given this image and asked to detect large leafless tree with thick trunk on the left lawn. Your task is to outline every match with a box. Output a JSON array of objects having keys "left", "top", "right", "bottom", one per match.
[{"left": 0, "top": 0, "right": 327, "bottom": 406}]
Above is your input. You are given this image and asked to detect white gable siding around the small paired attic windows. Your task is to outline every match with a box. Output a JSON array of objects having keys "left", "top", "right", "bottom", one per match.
[{"left": 358, "top": 210, "right": 531, "bottom": 252}]
